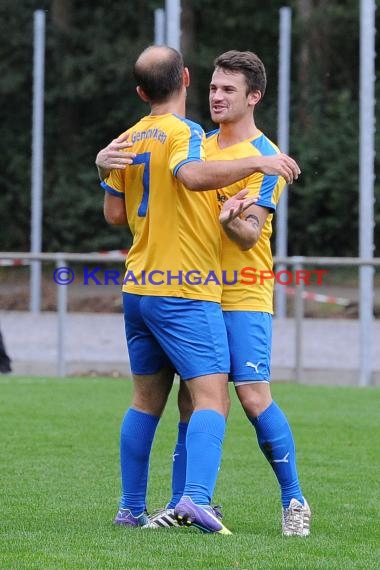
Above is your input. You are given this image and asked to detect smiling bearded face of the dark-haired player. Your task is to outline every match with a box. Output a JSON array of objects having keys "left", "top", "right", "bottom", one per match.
[{"left": 209, "top": 67, "right": 261, "bottom": 124}]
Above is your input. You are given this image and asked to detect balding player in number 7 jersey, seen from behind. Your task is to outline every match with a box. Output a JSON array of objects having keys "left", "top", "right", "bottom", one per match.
[{"left": 97, "top": 47, "right": 299, "bottom": 534}]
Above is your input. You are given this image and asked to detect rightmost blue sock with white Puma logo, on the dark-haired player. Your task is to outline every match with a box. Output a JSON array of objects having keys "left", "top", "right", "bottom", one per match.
[{"left": 250, "top": 402, "right": 304, "bottom": 508}]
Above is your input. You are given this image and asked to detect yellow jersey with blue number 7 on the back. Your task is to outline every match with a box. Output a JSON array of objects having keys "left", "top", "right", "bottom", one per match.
[{"left": 102, "top": 114, "right": 222, "bottom": 302}]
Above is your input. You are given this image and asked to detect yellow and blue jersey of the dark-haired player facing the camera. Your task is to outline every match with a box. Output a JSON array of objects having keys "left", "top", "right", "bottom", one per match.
[{"left": 205, "top": 130, "right": 285, "bottom": 313}]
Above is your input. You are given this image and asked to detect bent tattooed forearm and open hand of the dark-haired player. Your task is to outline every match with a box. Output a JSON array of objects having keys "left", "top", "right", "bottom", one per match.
[{"left": 219, "top": 188, "right": 269, "bottom": 250}]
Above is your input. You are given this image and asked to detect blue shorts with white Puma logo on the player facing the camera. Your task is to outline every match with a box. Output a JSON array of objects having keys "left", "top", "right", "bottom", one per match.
[{"left": 223, "top": 311, "right": 272, "bottom": 386}]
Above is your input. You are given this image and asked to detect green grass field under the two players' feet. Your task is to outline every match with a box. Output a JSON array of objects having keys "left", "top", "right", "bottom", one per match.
[{"left": 0, "top": 377, "right": 380, "bottom": 570}]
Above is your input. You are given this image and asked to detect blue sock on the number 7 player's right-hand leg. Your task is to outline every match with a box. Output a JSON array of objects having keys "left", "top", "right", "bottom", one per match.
[{"left": 183, "top": 410, "right": 226, "bottom": 505}]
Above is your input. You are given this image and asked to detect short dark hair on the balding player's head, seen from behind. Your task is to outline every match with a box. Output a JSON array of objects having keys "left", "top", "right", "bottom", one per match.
[{"left": 133, "top": 46, "right": 184, "bottom": 103}]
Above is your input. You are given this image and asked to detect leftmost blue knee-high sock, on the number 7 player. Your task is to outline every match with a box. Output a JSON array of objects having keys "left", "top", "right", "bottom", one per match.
[{"left": 120, "top": 408, "right": 160, "bottom": 516}]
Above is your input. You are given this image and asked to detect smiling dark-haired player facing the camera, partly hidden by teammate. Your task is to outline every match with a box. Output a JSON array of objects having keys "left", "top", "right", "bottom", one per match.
[{"left": 147, "top": 51, "right": 311, "bottom": 536}]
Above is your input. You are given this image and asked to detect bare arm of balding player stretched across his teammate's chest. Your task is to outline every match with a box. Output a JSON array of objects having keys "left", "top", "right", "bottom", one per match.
[{"left": 176, "top": 153, "right": 301, "bottom": 190}]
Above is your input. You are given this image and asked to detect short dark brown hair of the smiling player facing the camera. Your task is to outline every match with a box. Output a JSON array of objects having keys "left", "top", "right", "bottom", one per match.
[{"left": 214, "top": 50, "right": 267, "bottom": 97}]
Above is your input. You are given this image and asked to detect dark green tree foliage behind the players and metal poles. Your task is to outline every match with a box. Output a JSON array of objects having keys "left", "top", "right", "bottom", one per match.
[{"left": 0, "top": 0, "right": 380, "bottom": 255}]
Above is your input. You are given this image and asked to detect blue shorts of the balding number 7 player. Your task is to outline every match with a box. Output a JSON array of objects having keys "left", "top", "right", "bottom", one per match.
[{"left": 123, "top": 293, "right": 230, "bottom": 380}]
